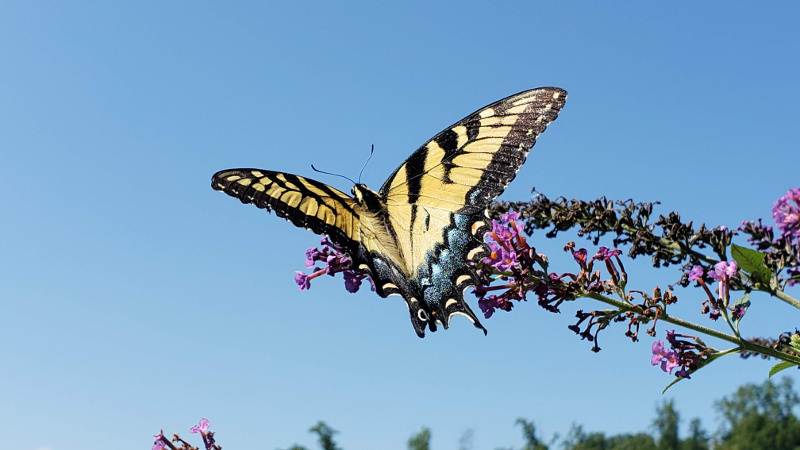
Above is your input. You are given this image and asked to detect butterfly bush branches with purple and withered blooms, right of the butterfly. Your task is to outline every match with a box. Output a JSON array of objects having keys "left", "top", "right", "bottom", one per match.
[{"left": 475, "top": 188, "right": 800, "bottom": 383}]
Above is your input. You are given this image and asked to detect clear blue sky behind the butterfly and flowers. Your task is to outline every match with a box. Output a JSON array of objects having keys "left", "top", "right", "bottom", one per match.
[{"left": 0, "top": 2, "right": 800, "bottom": 450}]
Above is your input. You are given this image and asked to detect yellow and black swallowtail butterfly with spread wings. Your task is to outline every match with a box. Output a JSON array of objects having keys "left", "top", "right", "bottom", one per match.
[{"left": 211, "top": 87, "right": 567, "bottom": 337}]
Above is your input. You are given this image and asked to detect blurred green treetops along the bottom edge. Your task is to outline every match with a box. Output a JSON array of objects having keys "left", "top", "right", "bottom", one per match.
[{"left": 280, "top": 378, "right": 800, "bottom": 450}]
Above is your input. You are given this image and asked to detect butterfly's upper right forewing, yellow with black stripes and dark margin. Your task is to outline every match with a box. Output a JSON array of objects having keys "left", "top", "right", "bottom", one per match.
[{"left": 380, "top": 88, "right": 567, "bottom": 214}]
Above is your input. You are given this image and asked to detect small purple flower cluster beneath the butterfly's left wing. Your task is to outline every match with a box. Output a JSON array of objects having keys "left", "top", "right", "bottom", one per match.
[{"left": 294, "top": 237, "right": 375, "bottom": 292}]
